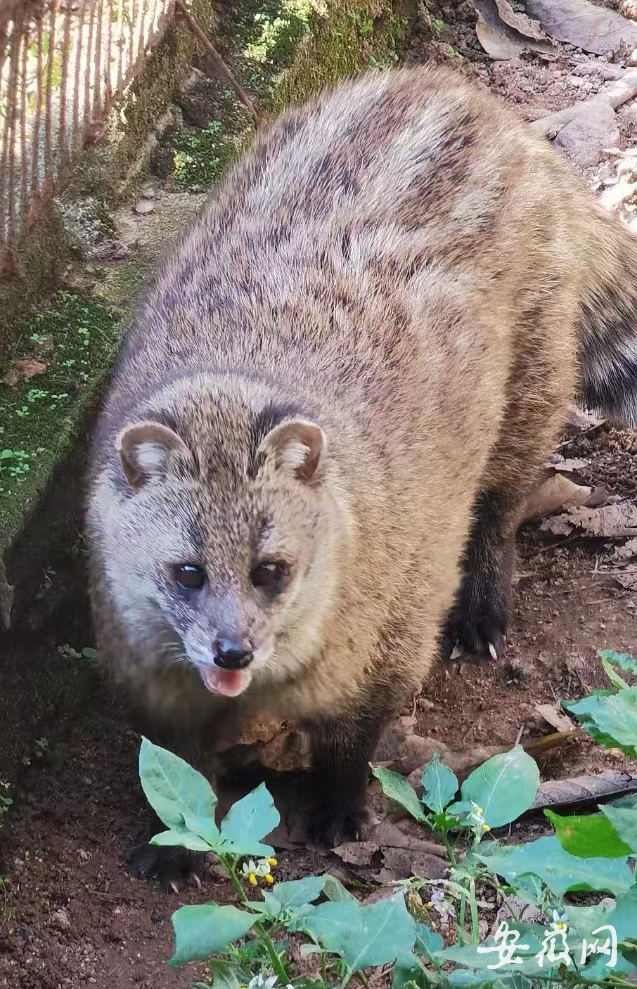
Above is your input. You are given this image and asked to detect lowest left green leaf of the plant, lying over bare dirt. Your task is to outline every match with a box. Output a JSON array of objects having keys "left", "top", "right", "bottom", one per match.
[{"left": 168, "top": 903, "right": 257, "bottom": 965}]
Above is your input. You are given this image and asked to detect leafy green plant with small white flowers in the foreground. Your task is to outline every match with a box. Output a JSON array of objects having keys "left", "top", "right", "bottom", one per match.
[{"left": 140, "top": 652, "right": 637, "bottom": 989}]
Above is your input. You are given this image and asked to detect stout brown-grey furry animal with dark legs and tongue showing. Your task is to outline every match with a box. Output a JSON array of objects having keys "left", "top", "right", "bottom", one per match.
[{"left": 88, "top": 63, "right": 637, "bottom": 869}]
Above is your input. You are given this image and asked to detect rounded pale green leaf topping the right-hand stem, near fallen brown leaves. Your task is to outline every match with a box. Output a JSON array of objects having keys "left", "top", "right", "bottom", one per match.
[{"left": 461, "top": 745, "right": 540, "bottom": 828}]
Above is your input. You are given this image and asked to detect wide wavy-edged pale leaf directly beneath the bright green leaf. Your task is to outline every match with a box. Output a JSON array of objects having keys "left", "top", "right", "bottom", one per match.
[{"left": 475, "top": 835, "right": 632, "bottom": 896}]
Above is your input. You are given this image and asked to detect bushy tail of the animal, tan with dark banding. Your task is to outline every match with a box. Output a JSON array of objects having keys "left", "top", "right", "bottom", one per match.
[{"left": 580, "top": 208, "right": 637, "bottom": 428}]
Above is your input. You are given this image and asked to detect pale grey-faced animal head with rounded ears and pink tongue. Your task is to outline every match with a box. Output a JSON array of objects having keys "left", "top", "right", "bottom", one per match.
[{"left": 94, "top": 380, "right": 347, "bottom": 697}]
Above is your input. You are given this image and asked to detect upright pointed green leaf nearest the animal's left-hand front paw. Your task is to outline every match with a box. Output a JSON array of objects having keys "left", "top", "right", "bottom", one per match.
[{"left": 139, "top": 738, "right": 217, "bottom": 829}]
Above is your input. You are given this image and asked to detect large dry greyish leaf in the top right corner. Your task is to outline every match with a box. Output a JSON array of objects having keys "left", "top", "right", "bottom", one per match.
[{"left": 525, "top": 0, "right": 637, "bottom": 55}]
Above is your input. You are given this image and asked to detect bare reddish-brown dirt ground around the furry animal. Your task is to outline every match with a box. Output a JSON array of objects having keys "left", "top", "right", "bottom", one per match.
[{"left": 0, "top": 3, "right": 637, "bottom": 989}]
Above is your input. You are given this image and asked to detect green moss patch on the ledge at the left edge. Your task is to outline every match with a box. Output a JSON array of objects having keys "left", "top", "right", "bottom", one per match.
[{"left": 0, "top": 292, "right": 119, "bottom": 556}]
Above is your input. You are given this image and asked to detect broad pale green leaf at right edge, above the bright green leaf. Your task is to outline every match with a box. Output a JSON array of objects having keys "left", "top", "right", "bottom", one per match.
[{"left": 562, "top": 687, "right": 637, "bottom": 758}]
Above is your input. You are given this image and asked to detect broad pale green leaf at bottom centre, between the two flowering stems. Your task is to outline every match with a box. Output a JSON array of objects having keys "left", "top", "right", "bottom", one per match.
[{"left": 297, "top": 894, "right": 416, "bottom": 972}]
